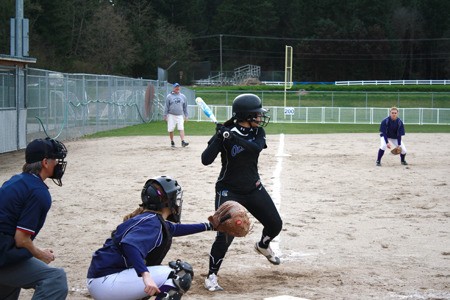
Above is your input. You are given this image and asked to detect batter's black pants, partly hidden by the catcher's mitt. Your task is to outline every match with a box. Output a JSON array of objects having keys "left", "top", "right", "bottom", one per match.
[{"left": 209, "top": 184, "right": 283, "bottom": 274}]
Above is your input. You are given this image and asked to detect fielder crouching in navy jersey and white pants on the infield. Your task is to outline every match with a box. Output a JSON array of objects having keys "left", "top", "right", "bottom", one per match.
[{"left": 376, "top": 107, "right": 408, "bottom": 167}]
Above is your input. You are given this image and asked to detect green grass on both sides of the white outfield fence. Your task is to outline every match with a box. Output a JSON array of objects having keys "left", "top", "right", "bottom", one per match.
[{"left": 81, "top": 85, "right": 450, "bottom": 138}]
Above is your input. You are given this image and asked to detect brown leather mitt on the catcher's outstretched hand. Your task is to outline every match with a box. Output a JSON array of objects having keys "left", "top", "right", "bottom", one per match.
[{"left": 208, "top": 201, "right": 250, "bottom": 237}]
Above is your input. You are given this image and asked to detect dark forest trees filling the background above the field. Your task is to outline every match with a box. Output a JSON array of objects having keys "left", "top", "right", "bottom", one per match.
[{"left": 0, "top": 0, "right": 450, "bottom": 81}]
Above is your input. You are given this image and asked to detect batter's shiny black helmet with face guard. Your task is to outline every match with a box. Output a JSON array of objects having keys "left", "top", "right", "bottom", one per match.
[{"left": 232, "top": 94, "right": 270, "bottom": 127}]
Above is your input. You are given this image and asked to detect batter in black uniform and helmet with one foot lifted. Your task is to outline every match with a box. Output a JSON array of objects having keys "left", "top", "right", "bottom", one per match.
[{"left": 201, "top": 94, "right": 282, "bottom": 291}]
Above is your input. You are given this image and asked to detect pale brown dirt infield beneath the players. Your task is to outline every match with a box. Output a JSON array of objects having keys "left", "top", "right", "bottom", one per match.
[{"left": 0, "top": 133, "right": 450, "bottom": 300}]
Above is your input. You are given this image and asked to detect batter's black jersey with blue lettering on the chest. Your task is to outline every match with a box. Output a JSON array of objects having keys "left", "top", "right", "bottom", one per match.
[{"left": 202, "top": 126, "right": 267, "bottom": 194}]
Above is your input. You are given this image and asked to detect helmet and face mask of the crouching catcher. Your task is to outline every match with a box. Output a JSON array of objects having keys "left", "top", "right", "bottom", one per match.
[{"left": 141, "top": 176, "right": 183, "bottom": 223}]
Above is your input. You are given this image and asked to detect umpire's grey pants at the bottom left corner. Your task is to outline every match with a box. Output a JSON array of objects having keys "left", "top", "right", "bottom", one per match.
[{"left": 0, "top": 257, "right": 68, "bottom": 300}]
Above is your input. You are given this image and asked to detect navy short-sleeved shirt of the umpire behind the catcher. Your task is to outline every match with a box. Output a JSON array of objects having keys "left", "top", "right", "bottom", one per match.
[{"left": 0, "top": 173, "right": 52, "bottom": 239}]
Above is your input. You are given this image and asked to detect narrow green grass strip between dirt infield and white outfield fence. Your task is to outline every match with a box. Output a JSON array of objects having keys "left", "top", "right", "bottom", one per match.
[{"left": 86, "top": 121, "right": 450, "bottom": 138}]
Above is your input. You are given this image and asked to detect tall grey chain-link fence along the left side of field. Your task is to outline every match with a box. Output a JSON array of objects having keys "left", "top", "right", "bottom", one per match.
[{"left": 0, "top": 68, "right": 195, "bottom": 153}]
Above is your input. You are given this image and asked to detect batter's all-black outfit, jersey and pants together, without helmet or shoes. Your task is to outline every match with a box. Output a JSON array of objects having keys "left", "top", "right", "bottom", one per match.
[{"left": 202, "top": 124, "right": 283, "bottom": 274}]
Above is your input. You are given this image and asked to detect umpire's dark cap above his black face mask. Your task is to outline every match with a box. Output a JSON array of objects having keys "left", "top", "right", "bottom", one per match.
[{"left": 25, "top": 138, "right": 65, "bottom": 164}]
